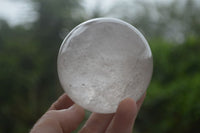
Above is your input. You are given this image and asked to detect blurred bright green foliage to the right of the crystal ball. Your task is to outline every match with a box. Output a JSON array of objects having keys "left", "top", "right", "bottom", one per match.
[{"left": 136, "top": 38, "right": 200, "bottom": 133}]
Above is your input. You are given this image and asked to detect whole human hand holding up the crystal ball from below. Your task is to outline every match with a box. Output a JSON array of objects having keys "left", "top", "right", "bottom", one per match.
[{"left": 30, "top": 94, "right": 145, "bottom": 133}]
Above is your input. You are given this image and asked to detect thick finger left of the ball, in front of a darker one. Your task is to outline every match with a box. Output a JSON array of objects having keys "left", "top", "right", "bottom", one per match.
[{"left": 31, "top": 104, "right": 84, "bottom": 133}]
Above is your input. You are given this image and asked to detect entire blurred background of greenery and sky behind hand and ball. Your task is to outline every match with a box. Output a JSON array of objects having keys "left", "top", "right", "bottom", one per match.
[{"left": 0, "top": 0, "right": 200, "bottom": 133}]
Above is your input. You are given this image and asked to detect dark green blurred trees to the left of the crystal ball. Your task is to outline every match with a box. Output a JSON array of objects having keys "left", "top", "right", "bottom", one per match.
[{"left": 0, "top": 0, "right": 85, "bottom": 133}]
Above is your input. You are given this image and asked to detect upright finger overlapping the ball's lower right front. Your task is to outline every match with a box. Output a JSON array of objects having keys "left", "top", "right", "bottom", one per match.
[{"left": 107, "top": 98, "right": 137, "bottom": 133}]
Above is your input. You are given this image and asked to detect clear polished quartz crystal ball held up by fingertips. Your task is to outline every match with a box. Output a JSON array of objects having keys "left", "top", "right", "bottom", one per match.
[{"left": 58, "top": 18, "right": 153, "bottom": 113}]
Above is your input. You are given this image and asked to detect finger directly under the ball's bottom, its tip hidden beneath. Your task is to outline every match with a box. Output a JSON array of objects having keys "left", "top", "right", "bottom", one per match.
[{"left": 79, "top": 113, "right": 114, "bottom": 133}]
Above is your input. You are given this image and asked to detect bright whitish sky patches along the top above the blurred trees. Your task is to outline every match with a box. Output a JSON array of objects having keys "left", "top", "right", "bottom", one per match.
[{"left": 0, "top": 0, "right": 172, "bottom": 25}]
